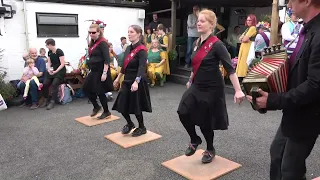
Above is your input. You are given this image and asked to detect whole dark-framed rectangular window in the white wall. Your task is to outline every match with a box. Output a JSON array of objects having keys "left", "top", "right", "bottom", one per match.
[{"left": 36, "top": 13, "right": 79, "bottom": 37}]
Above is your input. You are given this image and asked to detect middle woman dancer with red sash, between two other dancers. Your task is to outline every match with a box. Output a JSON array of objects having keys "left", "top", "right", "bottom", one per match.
[{"left": 112, "top": 25, "right": 152, "bottom": 137}]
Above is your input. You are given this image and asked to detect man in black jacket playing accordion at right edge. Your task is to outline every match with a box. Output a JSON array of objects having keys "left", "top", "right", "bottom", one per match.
[{"left": 248, "top": 0, "right": 320, "bottom": 180}]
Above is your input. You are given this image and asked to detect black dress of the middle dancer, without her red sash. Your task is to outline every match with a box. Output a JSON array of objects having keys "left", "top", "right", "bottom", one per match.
[{"left": 112, "top": 43, "right": 152, "bottom": 114}]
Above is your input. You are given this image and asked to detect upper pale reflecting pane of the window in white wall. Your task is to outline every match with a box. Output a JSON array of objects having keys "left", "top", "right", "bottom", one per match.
[{"left": 37, "top": 14, "right": 78, "bottom": 25}]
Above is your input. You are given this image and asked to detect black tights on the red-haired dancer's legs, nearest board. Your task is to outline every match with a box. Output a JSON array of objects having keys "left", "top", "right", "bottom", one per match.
[{"left": 179, "top": 114, "right": 214, "bottom": 151}]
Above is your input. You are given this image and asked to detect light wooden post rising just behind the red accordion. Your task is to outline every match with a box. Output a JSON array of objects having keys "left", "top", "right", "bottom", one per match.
[{"left": 270, "top": 0, "right": 279, "bottom": 46}]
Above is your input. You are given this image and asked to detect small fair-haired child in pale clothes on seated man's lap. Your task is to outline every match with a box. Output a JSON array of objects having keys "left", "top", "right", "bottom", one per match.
[{"left": 21, "top": 59, "right": 43, "bottom": 99}]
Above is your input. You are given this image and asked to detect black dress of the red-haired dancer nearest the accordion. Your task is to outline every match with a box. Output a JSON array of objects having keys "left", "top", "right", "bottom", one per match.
[{"left": 178, "top": 35, "right": 235, "bottom": 130}]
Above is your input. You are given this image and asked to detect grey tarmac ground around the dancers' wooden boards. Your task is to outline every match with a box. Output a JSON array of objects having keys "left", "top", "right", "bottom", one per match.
[{"left": 0, "top": 83, "right": 320, "bottom": 180}]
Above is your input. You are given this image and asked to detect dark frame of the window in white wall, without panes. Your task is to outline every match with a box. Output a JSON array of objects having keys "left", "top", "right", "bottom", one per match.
[{"left": 36, "top": 12, "right": 79, "bottom": 37}]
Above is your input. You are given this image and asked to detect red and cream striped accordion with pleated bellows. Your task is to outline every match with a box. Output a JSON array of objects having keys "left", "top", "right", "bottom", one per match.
[{"left": 242, "top": 44, "right": 289, "bottom": 114}]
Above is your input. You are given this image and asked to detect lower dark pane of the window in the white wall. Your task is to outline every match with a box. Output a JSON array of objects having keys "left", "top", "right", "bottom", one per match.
[{"left": 38, "top": 25, "right": 78, "bottom": 37}]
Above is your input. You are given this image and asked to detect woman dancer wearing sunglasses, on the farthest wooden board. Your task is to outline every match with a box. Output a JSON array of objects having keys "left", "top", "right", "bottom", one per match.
[{"left": 83, "top": 24, "right": 113, "bottom": 119}]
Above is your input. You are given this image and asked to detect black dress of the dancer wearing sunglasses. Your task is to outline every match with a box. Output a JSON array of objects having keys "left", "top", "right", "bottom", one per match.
[{"left": 83, "top": 40, "right": 113, "bottom": 95}]
